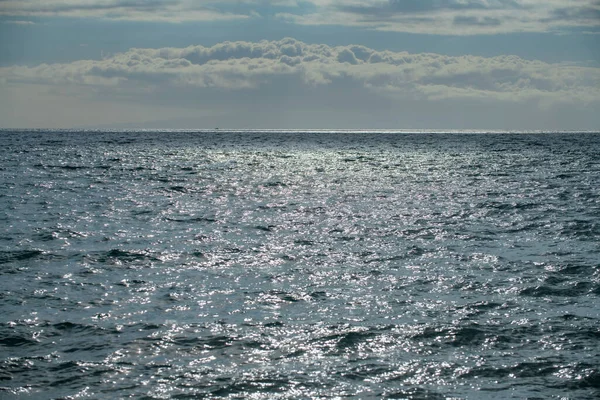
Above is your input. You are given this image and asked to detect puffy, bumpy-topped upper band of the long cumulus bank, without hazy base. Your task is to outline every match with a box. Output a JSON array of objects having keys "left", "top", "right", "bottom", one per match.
[{"left": 0, "top": 38, "right": 600, "bottom": 102}]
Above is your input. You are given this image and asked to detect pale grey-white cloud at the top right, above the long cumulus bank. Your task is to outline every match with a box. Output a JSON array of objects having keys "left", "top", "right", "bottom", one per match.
[{"left": 280, "top": 0, "right": 600, "bottom": 35}]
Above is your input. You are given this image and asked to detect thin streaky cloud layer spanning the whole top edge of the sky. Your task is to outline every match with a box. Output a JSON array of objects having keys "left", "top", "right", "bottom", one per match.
[{"left": 0, "top": 0, "right": 600, "bottom": 35}]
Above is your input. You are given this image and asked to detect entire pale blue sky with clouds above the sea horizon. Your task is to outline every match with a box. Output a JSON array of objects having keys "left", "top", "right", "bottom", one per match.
[{"left": 0, "top": 0, "right": 600, "bottom": 131}]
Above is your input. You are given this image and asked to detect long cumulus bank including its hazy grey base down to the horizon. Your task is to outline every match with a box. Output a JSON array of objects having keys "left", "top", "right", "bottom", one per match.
[{"left": 0, "top": 38, "right": 600, "bottom": 129}]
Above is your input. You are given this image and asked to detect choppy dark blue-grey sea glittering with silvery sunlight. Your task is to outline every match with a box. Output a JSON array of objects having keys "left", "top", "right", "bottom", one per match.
[{"left": 0, "top": 131, "right": 600, "bottom": 399}]
